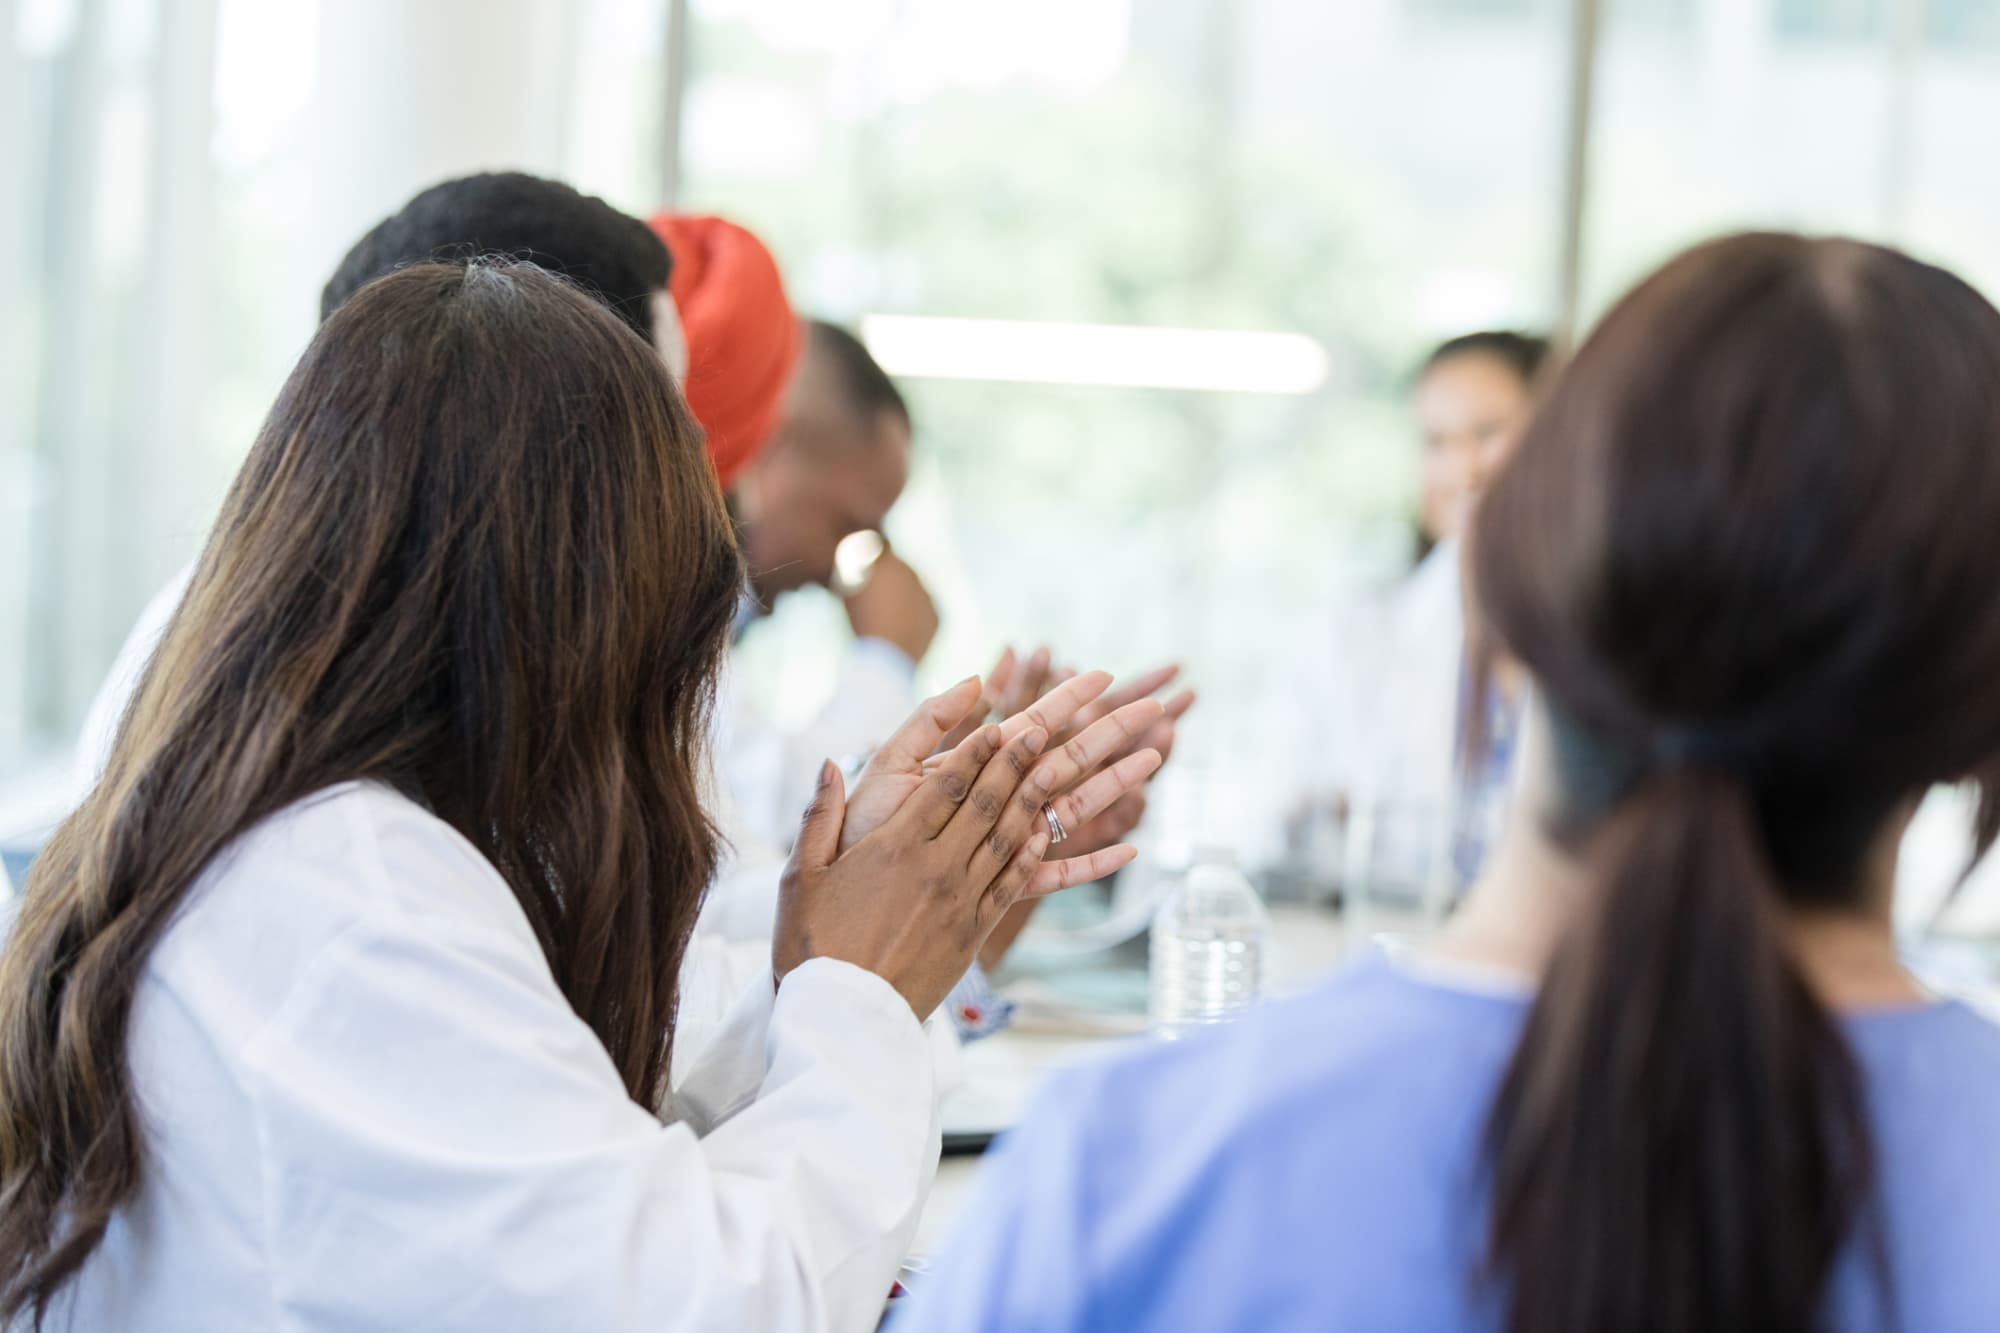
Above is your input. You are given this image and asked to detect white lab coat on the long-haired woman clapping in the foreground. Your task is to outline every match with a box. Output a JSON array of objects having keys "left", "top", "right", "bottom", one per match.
[{"left": 50, "top": 783, "right": 938, "bottom": 1333}]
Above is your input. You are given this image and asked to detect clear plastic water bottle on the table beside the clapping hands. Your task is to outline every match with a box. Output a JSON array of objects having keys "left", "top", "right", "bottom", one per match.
[{"left": 1148, "top": 853, "right": 1270, "bottom": 1041}]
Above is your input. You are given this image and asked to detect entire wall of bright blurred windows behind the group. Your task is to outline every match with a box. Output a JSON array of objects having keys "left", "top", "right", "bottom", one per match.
[{"left": 0, "top": 0, "right": 2000, "bottom": 837}]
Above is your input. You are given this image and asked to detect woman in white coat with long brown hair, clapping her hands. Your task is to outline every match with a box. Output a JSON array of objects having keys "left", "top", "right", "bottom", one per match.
[{"left": 0, "top": 262, "right": 1158, "bottom": 1331}]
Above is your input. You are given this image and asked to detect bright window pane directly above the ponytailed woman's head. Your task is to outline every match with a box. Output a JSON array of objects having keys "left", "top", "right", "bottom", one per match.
[{"left": 1584, "top": 0, "right": 2000, "bottom": 312}]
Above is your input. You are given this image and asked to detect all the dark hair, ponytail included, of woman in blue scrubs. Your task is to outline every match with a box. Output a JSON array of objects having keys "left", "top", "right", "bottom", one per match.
[{"left": 1472, "top": 234, "right": 2000, "bottom": 1333}]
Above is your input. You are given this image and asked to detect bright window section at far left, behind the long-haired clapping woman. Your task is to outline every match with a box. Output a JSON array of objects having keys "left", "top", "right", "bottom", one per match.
[{"left": 0, "top": 0, "right": 668, "bottom": 839}]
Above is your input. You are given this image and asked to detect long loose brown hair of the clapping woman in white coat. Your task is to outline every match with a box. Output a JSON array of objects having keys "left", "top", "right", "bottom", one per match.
[{"left": 0, "top": 262, "right": 742, "bottom": 1323}]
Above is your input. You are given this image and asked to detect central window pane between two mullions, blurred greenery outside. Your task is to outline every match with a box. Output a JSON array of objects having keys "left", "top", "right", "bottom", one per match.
[{"left": 682, "top": 0, "right": 1566, "bottom": 837}]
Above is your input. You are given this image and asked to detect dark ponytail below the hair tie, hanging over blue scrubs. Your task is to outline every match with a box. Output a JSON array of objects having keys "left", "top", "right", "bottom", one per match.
[{"left": 1486, "top": 763, "right": 1872, "bottom": 1333}]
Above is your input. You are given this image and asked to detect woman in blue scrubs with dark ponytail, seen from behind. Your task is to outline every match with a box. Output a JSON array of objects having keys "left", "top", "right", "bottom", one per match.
[{"left": 898, "top": 234, "right": 2000, "bottom": 1333}]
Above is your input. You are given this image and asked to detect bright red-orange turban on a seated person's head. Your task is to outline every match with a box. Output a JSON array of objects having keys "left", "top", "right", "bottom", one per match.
[{"left": 652, "top": 212, "right": 800, "bottom": 490}]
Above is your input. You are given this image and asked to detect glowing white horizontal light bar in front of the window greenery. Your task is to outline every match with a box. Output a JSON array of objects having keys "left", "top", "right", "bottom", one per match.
[{"left": 862, "top": 314, "right": 1328, "bottom": 394}]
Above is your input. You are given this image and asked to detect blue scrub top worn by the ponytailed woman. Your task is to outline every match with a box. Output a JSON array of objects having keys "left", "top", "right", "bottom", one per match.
[{"left": 890, "top": 948, "right": 2000, "bottom": 1333}]
